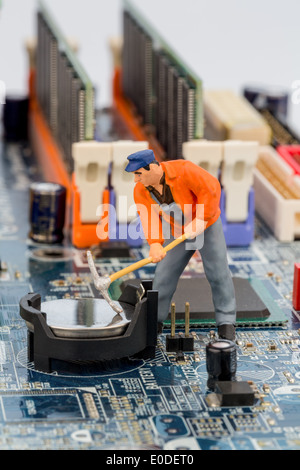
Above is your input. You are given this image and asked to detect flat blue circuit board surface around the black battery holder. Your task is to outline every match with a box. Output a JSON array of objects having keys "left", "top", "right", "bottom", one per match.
[{"left": 0, "top": 129, "right": 300, "bottom": 451}]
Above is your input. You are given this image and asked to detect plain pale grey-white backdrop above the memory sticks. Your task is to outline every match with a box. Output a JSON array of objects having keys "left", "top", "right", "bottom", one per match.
[{"left": 0, "top": 0, "right": 300, "bottom": 131}]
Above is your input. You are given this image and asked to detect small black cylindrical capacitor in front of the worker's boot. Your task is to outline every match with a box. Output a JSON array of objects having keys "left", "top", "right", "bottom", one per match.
[{"left": 206, "top": 339, "right": 237, "bottom": 389}]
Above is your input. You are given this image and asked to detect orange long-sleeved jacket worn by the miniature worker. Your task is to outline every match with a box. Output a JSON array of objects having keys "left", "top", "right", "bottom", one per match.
[{"left": 134, "top": 160, "right": 221, "bottom": 245}]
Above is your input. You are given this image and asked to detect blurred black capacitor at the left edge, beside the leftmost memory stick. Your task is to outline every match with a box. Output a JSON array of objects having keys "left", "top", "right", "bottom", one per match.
[{"left": 3, "top": 96, "right": 29, "bottom": 142}]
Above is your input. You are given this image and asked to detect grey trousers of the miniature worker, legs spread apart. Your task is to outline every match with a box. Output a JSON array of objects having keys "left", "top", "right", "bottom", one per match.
[{"left": 153, "top": 218, "right": 236, "bottom": 326}]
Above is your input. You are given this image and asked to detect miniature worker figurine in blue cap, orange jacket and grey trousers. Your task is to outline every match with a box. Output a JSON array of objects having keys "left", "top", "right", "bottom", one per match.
[{"left": 125, "top": 150, "right": 236, "bottom": 340}]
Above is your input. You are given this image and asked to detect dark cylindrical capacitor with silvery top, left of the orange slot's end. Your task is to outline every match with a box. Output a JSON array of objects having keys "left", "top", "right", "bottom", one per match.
[{"left": 29, "top": 183, "right": 66, "bottom": 244}]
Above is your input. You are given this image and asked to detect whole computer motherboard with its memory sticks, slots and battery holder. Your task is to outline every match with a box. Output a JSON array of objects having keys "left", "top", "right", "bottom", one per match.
[{"left": 0, "top": 0, "right": 300, "bottom": 456}]
